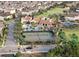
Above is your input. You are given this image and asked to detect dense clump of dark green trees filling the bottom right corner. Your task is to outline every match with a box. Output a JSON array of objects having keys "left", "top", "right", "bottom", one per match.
[{"left": 48, "top": 34, "right": 79, "bottom": 57}]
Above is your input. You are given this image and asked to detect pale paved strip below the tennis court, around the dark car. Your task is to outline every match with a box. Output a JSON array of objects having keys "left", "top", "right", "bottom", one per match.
[{"left": 20, "top": 45, "right": 56, "bottom": 53}]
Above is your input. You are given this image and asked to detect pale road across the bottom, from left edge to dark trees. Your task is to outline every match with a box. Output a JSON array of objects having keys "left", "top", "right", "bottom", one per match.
[{"left": 0, "top": 45, "right": 55, "bottom": 55}]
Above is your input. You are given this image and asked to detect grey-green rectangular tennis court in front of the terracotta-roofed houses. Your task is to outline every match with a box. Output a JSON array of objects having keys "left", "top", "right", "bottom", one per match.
[{"left": 24, "top": 32, "right": 54, "bottom": 42}]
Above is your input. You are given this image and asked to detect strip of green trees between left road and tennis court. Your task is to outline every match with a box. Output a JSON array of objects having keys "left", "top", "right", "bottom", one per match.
[{"left": 14, "top": 20, "right": 25, "bottom": 44}]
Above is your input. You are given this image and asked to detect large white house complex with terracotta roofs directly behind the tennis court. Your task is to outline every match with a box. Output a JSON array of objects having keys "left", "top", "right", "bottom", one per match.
[{"left": 21, "top": 16, "right": 55, "bottom": 31}]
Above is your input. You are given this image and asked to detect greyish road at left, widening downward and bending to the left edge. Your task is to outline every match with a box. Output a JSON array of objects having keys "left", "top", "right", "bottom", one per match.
[{"left": 0, "top": 20, "right": 18, "bottom": 55}]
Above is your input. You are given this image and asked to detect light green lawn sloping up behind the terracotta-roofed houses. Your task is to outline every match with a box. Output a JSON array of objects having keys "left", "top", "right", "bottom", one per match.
[{"left": 36, "top": 7, "right": 63, "bottom": 17}]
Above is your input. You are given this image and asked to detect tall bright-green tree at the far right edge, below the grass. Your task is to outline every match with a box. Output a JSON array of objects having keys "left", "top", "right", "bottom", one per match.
[{"left": 70, "top": 33, "right": 79, "bottom": 56}]
